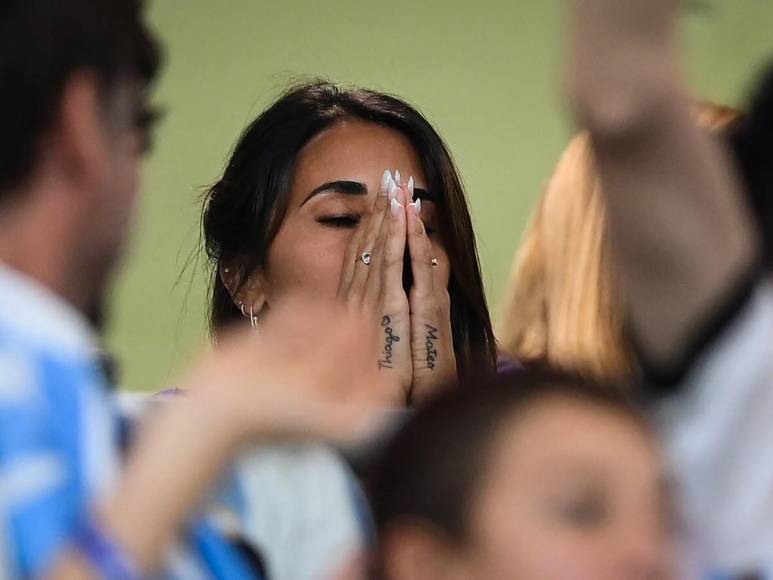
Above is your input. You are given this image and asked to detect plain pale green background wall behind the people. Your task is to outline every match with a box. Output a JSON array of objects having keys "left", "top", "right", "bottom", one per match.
[{"left": 108, "top": 0, "right": 773, "bottom": 390}]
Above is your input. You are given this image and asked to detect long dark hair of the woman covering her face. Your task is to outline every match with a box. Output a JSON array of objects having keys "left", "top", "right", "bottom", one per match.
[{"left": 202, "top": 81, "right": 496, "bottom": 375}]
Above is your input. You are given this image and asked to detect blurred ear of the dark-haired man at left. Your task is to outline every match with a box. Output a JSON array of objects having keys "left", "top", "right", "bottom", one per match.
[{"left": 51, "top": 72, "right": 110, "bottom": 192}]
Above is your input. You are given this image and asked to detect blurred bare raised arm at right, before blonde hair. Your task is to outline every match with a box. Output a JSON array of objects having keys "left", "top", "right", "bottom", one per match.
[{"left": 567, "top": 0, "right": 757, "bottom": 375}]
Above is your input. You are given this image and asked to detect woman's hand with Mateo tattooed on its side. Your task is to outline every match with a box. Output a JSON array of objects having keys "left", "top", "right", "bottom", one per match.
[{"left": 404, "top": 179, "right": 457, "bottom": 400}]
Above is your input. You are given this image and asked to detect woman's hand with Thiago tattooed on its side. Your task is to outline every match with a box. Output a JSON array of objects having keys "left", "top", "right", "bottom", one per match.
[{"left": 338, "top": 171, "right": 413, "bottom": 403}]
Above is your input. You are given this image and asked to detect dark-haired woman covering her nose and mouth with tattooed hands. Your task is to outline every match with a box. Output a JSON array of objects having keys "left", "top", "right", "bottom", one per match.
[{"left": 203, "top": 83, "right": 496, "bottom": 401}]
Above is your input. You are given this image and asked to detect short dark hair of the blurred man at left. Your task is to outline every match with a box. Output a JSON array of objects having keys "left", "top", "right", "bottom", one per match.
[{"left": 0, "top": 0, "right": 160, "bottom": 195}]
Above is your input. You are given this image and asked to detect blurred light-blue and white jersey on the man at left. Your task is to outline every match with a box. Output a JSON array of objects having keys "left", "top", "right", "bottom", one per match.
[{"left": 0, "top": 265, "right": 253, "bottom": 579}]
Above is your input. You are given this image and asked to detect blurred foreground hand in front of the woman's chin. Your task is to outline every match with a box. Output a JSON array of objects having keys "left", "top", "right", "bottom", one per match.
[{"left": 183, "top": 300, "right": 394, "bottom": 445}]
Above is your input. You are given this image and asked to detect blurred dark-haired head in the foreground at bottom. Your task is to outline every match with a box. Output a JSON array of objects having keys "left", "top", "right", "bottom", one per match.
[{"left": 370, "top": 371, "right": 674, "bottom": 580}]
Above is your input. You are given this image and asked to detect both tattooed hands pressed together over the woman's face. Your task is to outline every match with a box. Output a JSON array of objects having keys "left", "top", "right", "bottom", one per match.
[{"left": 338, "top": 170, "right": 456, "bottom": 397}]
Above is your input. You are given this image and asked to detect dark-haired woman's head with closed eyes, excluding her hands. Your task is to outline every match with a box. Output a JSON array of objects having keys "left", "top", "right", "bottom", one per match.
[{"left": 203, "top": 82, "right": 495, "bottom": 373}]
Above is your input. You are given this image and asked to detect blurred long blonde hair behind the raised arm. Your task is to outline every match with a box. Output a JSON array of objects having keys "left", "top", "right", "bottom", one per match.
[{"left": 498, "top": 104, "right": 738, "bottom": 383}]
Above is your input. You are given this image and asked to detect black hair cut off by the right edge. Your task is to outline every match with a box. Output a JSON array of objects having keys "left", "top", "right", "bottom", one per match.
[{"left": 731, "top": 66, "right": 773, "bottom": 270}]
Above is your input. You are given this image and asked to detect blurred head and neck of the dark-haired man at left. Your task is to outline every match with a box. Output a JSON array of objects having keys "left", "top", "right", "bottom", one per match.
[{"left": 0, "top": 0, "right": 159, "bottom": 324}]
